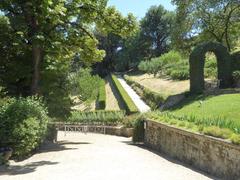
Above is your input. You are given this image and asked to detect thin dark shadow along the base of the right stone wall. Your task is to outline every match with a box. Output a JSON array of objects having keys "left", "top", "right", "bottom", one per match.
[{"left": 121, "top": 141, "right": 219, "bottom": 180}]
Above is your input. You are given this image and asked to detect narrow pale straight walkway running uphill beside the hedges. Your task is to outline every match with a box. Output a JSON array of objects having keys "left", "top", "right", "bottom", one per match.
[{"left": 118, "top": 77, "right": 151, "bottom": 112}]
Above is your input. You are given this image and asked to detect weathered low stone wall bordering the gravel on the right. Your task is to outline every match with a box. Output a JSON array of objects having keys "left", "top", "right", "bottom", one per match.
[{"left": 144, "top": 120, "right": 240, "bottom": 180}]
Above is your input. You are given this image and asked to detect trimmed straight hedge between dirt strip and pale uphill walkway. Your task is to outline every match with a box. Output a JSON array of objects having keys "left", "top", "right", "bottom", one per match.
[{"left": 111, "top": 74, "right": 139, "bottom": 114}]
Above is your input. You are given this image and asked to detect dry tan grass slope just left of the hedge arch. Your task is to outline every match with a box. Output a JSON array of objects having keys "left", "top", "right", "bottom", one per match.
[{"left": 128, "top": 74, "right": 189, "bottom": 96}]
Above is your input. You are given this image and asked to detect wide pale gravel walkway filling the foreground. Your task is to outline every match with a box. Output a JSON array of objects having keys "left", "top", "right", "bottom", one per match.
[{"left": 0, "top": 132, "right": 214, "bottom": 180}]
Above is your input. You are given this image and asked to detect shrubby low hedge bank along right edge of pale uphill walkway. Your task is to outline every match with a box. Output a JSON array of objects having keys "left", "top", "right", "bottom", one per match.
[{"left": 124, "top": 75, "right": 167, "bottom": 110}]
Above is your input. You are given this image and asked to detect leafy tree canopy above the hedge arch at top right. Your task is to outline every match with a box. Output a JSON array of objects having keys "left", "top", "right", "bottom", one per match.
[{"left": 173, "top": 0, "right": 240, "bottom": 51}]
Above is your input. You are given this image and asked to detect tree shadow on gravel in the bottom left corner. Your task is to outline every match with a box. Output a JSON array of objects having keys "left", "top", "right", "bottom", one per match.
[{"left": 0, "top": 161, "right": 58, "bottom": 175}]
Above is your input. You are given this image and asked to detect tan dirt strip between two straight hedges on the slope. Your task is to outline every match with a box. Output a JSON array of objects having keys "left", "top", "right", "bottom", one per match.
[{"left": 105, "top": 76, "right": 124, "bottom": 110}]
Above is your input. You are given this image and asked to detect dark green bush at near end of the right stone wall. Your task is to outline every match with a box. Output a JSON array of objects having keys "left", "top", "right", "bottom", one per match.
[{"left": 132, "top": 117, "right": 144, "bottom": 142}]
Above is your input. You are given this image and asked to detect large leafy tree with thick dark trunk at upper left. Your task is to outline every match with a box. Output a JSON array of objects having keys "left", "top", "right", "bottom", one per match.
[{"left": 0, "top": 0, "right": 137, "bottom": 94}]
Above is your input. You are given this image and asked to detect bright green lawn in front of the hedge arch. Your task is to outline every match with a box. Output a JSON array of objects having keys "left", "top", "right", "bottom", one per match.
[{"left": 171, "top": 94, "right": 240, "bottom": 122}]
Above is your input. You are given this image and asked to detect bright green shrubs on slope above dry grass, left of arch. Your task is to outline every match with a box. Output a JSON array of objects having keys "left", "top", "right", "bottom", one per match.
[{"left": 138, "top": 51, "right": 189, "bottom": 80}]
